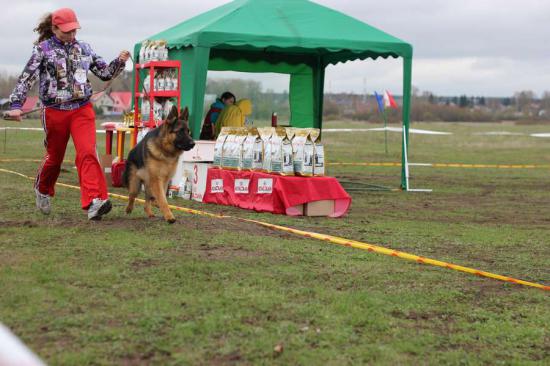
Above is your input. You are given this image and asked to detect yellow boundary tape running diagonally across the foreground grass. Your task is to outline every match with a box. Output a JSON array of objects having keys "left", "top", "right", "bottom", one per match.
[{"left": 0, "top": 168, "right": 550, "bottom": 291}]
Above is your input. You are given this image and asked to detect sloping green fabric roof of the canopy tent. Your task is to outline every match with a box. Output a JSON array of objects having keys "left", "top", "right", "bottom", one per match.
[{"left": 150, "top": 0, "right": 412, "bottom": 63}]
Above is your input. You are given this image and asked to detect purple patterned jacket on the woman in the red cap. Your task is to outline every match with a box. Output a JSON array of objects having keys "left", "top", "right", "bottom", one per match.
[{"left": 9, "top": 36, "right": 125, "bottom": 110}]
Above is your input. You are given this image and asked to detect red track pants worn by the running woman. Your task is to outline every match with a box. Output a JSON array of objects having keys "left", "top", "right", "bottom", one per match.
[{"left": 35, "top": 103, "right": 107, "bottom": 209}]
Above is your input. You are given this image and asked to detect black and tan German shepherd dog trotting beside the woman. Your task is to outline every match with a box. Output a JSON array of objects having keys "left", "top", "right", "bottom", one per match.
[{"left": 122, "top": 106, "right": 195, "bottom": 224}]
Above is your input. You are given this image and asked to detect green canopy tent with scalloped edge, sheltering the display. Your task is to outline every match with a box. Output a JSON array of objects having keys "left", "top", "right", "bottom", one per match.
[{"left": 134, "top": 0, "right": 412, "bottom": 189}]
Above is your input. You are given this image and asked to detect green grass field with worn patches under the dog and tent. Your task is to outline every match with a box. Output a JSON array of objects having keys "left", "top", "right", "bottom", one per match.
[{"left": 0, "top": 121, "right": 550, "bottom": 365}]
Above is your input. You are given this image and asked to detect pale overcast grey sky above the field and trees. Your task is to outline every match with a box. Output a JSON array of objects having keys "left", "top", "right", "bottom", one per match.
[{"left": 0, "top": 0, "right": 550, "bottom": 97}]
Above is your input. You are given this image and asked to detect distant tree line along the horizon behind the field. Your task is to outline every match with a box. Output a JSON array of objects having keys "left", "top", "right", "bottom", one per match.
[{"left": 0, "top": 71, "right": 550, "bottom": 123}]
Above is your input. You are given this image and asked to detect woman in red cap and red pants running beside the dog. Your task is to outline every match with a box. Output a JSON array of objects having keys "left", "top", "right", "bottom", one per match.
[{"left": 7, "top": 8, "right": 130, "bottom": 220}]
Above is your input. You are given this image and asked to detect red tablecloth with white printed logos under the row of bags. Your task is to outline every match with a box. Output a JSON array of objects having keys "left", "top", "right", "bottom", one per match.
[{"left": 203, "top": 168, "right": 351, "bottom": 217}]
